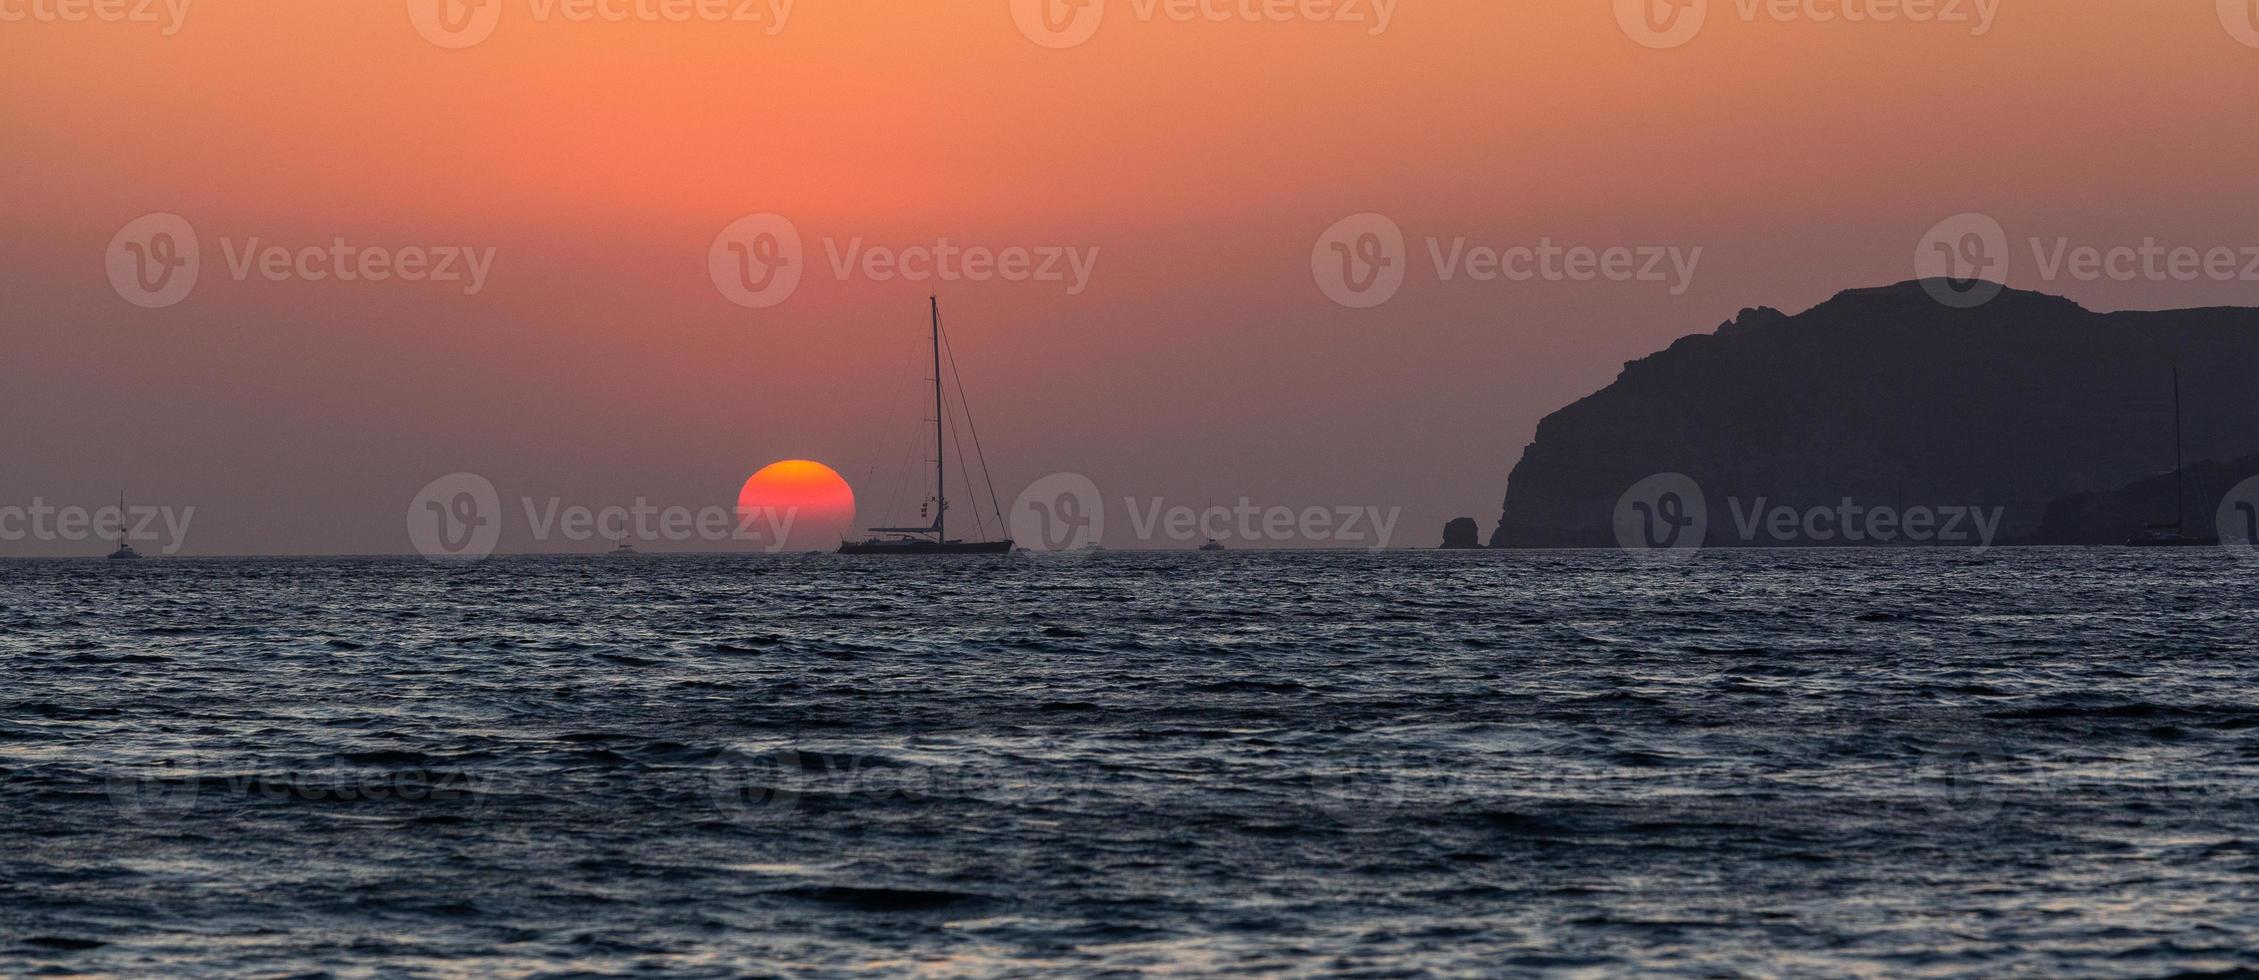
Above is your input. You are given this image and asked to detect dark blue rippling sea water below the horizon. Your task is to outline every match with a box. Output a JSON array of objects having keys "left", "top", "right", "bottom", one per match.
[{"left": 13, "top": 549, "right": 2259, "bottom": 975}]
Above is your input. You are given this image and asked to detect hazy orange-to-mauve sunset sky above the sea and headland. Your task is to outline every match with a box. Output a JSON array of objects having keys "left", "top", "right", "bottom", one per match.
[{"left": 0, "top": 0, "right": 2259, "bottom": 555}]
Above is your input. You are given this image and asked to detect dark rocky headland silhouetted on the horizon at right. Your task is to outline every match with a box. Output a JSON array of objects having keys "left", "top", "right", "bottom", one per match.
[{"left": 1491, "top": 282, "right": 2259, "bottom": 549}]
